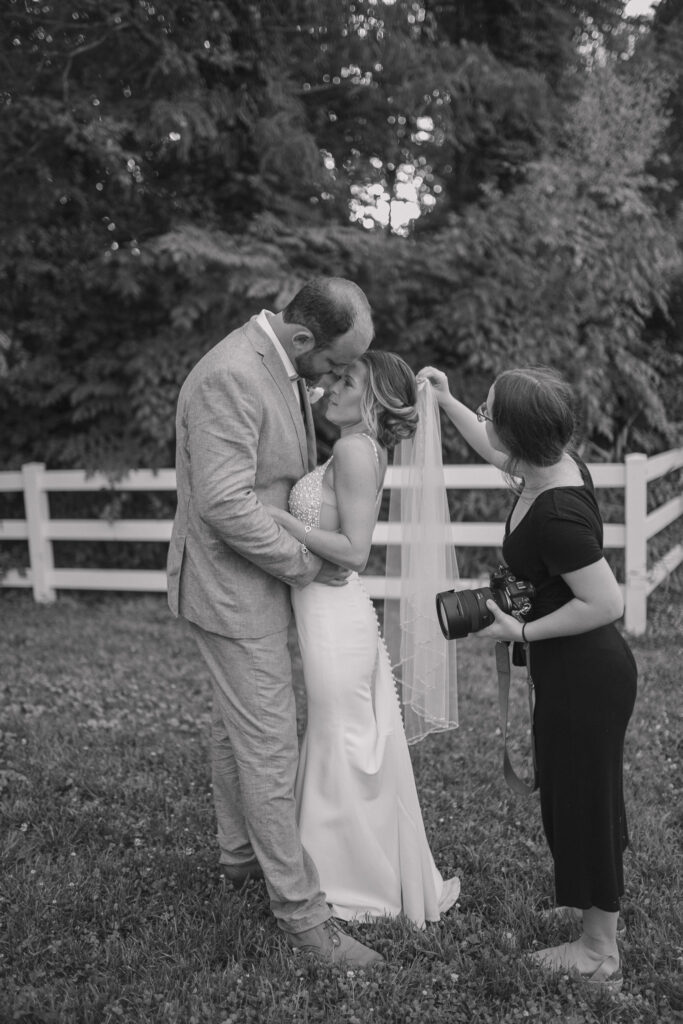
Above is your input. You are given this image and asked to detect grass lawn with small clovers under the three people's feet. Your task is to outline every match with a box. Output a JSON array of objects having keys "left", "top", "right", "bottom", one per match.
[{"left": 0, "top": 585, "right": 683, "bottom": 1024}]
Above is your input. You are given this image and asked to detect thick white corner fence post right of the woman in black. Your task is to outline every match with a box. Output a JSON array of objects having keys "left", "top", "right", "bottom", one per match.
[{"left": 624, "top": 453, "right": 647, "bottom": 636}]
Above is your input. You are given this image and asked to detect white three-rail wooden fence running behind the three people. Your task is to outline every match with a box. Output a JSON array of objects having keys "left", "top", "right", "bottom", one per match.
[{"left": 0, "top": 447, "right": 683, "bottom": 635}]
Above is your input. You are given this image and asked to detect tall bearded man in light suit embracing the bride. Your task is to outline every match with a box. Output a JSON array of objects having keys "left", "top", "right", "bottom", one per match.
[{"left": 163, "top": 278, "right": 382, "bottom": 967}]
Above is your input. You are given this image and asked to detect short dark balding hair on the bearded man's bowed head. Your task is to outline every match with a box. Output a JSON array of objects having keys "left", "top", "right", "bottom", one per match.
[{"left": 283, "top": 278, "right": 372, "bottom": 349}]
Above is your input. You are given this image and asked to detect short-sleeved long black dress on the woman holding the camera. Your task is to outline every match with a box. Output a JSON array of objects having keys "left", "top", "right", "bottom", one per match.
[{"left": 503, "top": 460, "right": 637, "bottom": 911}]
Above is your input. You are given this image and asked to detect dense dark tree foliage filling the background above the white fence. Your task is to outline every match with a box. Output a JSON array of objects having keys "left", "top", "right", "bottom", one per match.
[{"left": 0, "top": 0, "right": 683, "bottom": 472}]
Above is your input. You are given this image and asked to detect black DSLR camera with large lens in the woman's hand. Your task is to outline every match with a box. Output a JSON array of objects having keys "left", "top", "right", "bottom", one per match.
[{"left": 436, "top": 564, "right": 536, "bottom": 640}]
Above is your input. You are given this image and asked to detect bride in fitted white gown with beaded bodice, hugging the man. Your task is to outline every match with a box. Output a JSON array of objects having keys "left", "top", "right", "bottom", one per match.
[{"left": 268, "top": 350, "right": 460, "bottom": 928}]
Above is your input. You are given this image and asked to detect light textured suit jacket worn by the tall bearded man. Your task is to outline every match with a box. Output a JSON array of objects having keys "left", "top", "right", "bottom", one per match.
[{"left": 167, "top": 317, "right": 321, "bottom": 638}]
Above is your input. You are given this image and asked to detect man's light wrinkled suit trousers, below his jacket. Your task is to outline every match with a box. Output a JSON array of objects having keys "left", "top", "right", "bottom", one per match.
[{"left": 189, "top": 623, "right": 331, "bottom": 932}]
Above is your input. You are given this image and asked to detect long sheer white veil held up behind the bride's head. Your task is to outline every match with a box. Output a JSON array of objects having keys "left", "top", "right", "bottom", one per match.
[{"left": 384, "top": 381, "right": 458, "bottom": 743}]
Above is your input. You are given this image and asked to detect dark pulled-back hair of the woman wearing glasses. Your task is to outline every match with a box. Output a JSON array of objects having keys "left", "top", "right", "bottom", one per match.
[{"left": 490, "top": 367, "right": 577, "bottom": 476}]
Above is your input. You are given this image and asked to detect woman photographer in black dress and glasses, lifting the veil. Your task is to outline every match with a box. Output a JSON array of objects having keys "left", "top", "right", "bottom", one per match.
[{"left": 418, "top": 367, "right": 637, "bottom": 990}]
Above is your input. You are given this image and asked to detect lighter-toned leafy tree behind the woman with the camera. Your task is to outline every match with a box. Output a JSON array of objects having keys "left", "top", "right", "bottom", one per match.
[{"left": 397, "top": 67, "right": 681, "bottom": 458}]
